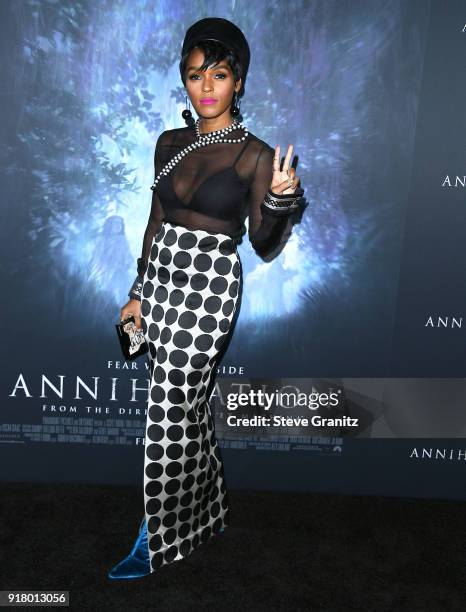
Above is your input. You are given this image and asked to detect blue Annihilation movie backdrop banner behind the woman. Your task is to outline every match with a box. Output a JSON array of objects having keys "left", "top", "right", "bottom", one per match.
[{"left": 0, "top": 0, "right": 466, "bottom": 499}]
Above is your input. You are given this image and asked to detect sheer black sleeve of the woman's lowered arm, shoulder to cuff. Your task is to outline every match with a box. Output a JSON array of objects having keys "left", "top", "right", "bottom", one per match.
[{"left": 128, "top": 132, "right": 166, "bottom": 301}]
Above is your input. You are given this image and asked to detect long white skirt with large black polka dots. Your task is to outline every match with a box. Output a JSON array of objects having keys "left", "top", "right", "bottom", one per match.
[{"left": 141, "top": 221, "right": 242, "bottom": 572}]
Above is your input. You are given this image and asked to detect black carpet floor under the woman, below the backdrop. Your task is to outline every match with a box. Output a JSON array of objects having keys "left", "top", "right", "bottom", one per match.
[{"left": 0, "top": 483, "right": 466, "bottom": 612}]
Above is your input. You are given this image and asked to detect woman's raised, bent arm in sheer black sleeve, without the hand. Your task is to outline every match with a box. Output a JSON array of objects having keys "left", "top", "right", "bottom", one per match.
[{"left": 248, "top": 145, "right": 304, "bottom": 258}]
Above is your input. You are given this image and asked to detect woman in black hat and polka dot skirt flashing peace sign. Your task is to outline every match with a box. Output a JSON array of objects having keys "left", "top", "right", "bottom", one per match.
[{"left": 109, "top": 18, "right": 303, "bottom": 579}]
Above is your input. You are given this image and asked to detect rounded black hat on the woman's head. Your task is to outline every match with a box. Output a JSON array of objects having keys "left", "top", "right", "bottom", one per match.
[{"left": 181, "top": 17, "right": 251, "bottom": 93}]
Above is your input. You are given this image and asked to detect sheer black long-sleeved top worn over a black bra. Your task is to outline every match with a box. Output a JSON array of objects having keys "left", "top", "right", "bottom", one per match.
[{"left": 128, "top": 127, "right": 303, "bottom": 297}]
